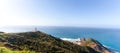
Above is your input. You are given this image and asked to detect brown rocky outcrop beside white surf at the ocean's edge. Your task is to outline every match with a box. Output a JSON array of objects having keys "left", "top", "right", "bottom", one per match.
[{"left": 75, "top": 38, "right": 113, "bottom": 53}]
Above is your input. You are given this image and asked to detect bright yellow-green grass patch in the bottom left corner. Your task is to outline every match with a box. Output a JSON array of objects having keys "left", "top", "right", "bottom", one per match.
[{"left": 0, "top": 47, "right": 35, "bottom": 53}]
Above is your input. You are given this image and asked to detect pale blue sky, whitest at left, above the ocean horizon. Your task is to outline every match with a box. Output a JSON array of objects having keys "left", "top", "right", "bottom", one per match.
[{"left": 0, "top": 0, "right": 120, "bottom": 28}]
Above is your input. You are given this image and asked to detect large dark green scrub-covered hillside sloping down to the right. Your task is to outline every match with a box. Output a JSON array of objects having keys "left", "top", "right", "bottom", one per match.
[{"left": 0, "top": 31, "right": 98, "bottom": 53}]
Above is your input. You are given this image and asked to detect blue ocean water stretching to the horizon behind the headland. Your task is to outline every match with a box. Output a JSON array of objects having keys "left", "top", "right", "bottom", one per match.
[{"left": 0, "top": 26, "right": 120, "bottom": 51}]
